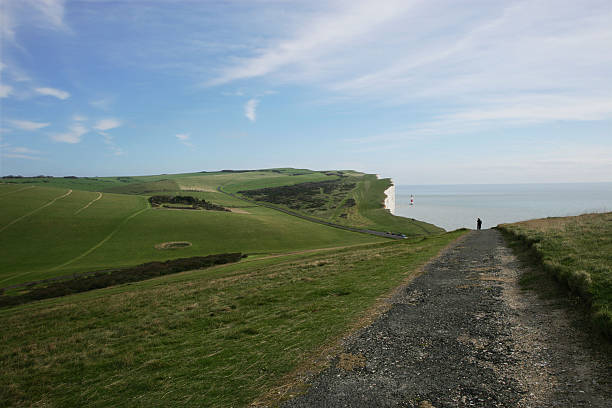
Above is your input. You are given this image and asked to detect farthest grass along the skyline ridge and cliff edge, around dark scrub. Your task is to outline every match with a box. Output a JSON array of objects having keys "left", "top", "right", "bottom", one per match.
[{"left": 4, "top": 168, "right": 443, "bottom": 235}]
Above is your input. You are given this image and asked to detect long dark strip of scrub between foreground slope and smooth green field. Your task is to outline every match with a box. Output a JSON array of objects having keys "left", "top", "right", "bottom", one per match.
[{"left": 0, "top": 252, "right": 246, "bottom": 307}]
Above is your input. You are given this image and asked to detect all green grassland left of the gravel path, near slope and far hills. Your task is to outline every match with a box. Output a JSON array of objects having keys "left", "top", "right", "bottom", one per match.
[{"left": 0, "top": 169, "right": 463, "bottom": 407}]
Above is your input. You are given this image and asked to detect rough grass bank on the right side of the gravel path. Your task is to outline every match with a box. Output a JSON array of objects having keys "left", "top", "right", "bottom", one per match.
[{"left": 498, "top": 212, "right": 612, "bottom": 339}]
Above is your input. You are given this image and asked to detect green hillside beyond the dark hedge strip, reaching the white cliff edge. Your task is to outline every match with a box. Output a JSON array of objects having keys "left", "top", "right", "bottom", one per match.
[{"left": 0, "top": 169, "right": 440, "bottom": 287}]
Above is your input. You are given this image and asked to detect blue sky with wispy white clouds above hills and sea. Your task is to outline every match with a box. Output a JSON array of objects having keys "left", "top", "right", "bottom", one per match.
[{"left": 0, "top": 0, "right": 612, "bottom": 184}]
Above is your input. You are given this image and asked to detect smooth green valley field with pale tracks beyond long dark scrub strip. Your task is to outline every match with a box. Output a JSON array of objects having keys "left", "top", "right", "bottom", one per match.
[{"left": 0, "top": 185, "right": 384, "bottom": 287}]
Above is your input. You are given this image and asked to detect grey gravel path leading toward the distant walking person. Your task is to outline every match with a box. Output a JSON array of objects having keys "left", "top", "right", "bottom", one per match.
[{"left": 283, "top": 230, "right": 612, "bottom": 408}]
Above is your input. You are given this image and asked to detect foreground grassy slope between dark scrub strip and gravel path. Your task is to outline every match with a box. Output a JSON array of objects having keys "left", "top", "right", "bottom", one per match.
[{"left": 0, "top": 232, "right": 462, "bottom": 407}]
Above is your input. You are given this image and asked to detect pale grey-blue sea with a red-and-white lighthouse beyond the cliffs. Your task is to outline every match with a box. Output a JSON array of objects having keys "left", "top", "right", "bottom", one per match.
[{"left": 394, "top": 183, "right": 612, "bottom": 231}]
